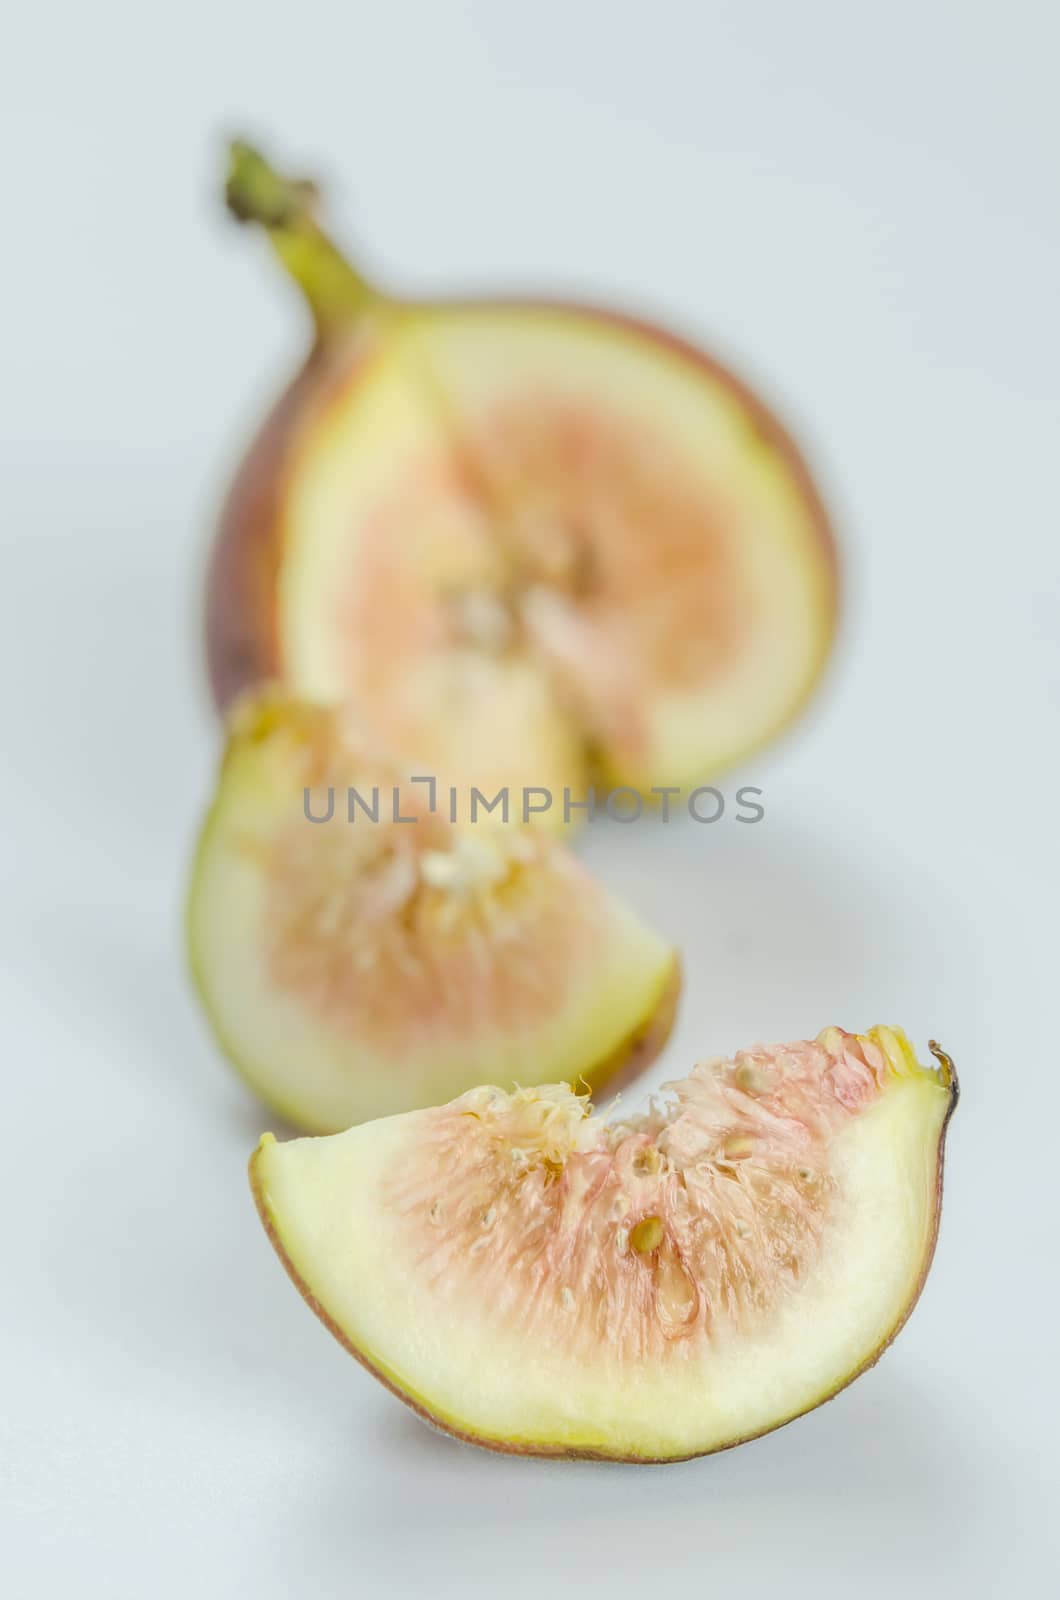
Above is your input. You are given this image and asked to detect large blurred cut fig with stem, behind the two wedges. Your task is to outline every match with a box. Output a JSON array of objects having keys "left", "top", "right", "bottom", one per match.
[{"left": 207, "top": 144, "right": 836, "bottom": 824}]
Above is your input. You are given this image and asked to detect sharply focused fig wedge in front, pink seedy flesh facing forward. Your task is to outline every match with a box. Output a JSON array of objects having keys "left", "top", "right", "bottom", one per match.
[{"left": 250, "top": 1027, "right": 958, "bottom": 1461}]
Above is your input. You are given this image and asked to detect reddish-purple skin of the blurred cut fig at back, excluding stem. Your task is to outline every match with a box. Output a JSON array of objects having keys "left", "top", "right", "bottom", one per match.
[{"left": 205, "top": 296, "right": 839, "bottom": 717}]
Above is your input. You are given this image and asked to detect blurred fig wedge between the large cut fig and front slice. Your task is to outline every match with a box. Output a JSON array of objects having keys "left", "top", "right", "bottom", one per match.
[{"left": 187, "top": 690, "right": 681, "bottom": 1133}]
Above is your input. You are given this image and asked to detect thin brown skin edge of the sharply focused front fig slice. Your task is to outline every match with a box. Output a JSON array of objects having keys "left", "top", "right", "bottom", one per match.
[{"left": 248, "top": 1038, "right": 961, "bottom": 1466}]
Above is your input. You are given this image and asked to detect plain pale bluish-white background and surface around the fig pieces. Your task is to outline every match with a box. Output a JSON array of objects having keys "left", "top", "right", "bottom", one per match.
[{"left": 0, "top": 0, "right": 1060, "bottom": 1600}]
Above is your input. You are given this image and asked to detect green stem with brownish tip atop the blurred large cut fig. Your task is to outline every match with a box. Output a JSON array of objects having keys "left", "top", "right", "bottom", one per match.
[{"left": 224, "top": 139, "right": 384, "bottom": 338}]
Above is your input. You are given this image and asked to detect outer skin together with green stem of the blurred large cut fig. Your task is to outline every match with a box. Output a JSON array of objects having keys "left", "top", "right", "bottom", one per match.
[{"left": 205, "top": 144, "right": 839, "bottom": 754}]
